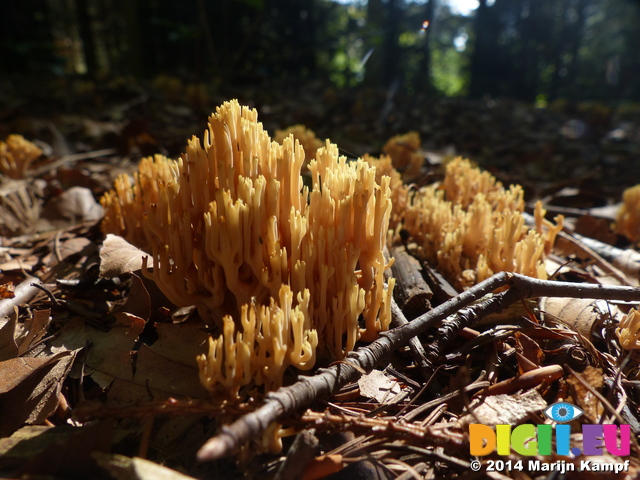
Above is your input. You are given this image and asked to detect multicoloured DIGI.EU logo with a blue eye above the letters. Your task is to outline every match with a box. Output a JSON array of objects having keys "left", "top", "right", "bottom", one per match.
[{"left": 469, "top": 402, "right": 631, "bottom": 457}]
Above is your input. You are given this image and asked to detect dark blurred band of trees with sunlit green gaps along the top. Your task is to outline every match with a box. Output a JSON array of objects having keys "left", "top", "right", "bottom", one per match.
[{"left": 0, "top": 0, "right": 640, "bottom": 103}]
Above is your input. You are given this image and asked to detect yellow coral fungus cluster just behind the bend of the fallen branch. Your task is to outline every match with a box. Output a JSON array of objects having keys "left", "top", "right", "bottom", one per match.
[{"left": 403, "top": 158, "right": 561, "bottom": 289}]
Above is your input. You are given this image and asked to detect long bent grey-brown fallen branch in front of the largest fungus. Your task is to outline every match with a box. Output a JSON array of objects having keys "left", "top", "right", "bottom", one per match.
[{"left": 198, "top": 272, "right": 640, "bottom": 461}]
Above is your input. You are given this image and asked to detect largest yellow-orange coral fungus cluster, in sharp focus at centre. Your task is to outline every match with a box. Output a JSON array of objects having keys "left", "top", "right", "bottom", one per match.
[{"left": 102, "top": 101, "right": 393, "bottom": 390}]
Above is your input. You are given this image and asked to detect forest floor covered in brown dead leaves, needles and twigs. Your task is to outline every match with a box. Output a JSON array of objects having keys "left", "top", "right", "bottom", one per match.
[{"left": 0, "top": 77, "right": 640, "bottom": 479}]
